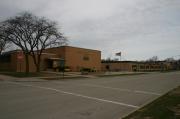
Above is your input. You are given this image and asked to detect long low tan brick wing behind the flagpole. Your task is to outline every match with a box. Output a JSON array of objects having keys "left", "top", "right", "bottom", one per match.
[{"left": 101, "top": 61, "right": 173, "bottom": 72}]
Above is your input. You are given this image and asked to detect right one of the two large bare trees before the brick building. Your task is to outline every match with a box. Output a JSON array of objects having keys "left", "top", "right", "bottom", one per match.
[{"left": 30, "top": 17, "right": 67, "bottom": 72}]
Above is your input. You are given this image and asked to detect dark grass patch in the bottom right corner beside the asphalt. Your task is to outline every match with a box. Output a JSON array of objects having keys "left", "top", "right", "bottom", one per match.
[{"left": 123, "top": 86, "right": 180, "bottom": 119}]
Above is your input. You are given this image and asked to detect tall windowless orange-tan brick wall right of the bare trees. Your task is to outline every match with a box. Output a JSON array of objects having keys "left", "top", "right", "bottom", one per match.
[{"left": 65, "top": 47, "right": 101, "bottom": 71}]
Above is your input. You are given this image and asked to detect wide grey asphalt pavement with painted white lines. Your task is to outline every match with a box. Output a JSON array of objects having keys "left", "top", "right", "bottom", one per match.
[{"left": 0, "top": 72, "right": 180, "bottom": 119}]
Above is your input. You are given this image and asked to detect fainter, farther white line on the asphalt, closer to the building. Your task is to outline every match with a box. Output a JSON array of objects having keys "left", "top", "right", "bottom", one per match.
[{"left": 55, "top": 82, "right": 161, "bottom": 96}]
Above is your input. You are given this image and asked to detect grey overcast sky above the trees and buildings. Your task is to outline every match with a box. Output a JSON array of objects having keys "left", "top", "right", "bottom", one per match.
[{"left": 0, "top": 0, "right": 180, "bottom": 60}]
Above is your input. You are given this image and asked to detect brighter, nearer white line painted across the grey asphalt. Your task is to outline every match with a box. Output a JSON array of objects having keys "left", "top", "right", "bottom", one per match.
[{"left": 8, "top": 82, "right": 139, "bottom": 108}]
